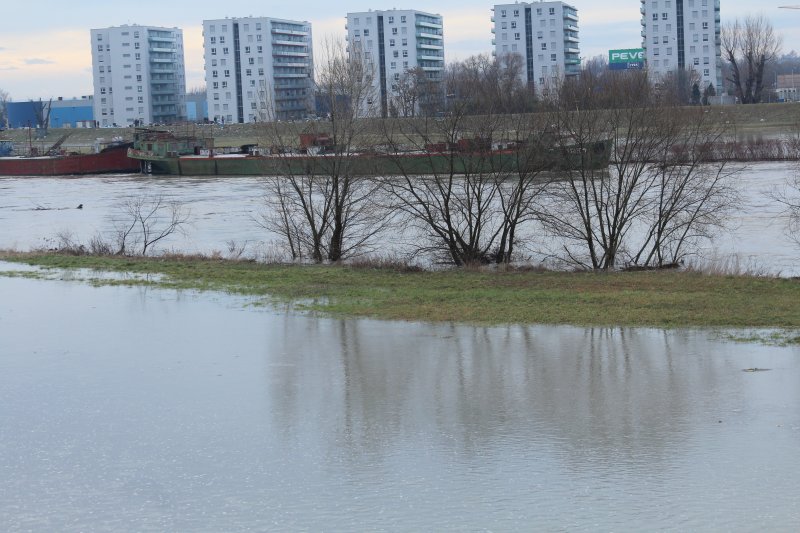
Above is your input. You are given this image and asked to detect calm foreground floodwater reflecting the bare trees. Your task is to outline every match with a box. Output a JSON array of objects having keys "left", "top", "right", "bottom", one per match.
[{"left": 0, "top": 263, "right": 800, "bottom": 532}]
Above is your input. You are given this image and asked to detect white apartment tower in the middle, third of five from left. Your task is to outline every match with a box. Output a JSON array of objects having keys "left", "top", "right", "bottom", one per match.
[{"left": 347, "top": 9, "right": 444, "bottom": 117}]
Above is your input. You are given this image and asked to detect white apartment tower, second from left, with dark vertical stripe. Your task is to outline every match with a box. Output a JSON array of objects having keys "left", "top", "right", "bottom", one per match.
[{"left": 203, "top": 17, "right": 314, "bottom": 124}]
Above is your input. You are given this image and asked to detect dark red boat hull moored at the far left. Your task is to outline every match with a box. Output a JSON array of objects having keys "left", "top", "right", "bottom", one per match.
[{"left": 0, "top": 145, "right": 141, "bottom": 176}]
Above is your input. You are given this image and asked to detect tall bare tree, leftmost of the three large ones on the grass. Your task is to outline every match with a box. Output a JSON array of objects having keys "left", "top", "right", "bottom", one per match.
[{"left": 261, "top": 40, "right": 387, "bottom": 262}]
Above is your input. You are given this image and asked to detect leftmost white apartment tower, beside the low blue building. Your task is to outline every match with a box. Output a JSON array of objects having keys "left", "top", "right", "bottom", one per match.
[{"left": 91, "top": 25, "right": 186, "bottom": 127}]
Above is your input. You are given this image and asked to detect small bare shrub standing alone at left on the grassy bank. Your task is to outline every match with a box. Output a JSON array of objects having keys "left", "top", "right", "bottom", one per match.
[{"left": 114, "top": 196, "right": 189, "bottom": 255}]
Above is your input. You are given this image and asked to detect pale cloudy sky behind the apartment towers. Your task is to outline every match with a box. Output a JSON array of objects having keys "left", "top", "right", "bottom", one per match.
[{"left": 0, "top": 0, "right": 800, "bottom": 101}]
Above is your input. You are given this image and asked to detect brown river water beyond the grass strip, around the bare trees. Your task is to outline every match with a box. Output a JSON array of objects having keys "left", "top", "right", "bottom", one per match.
[{"left": 0, "top": 163, "right": 800, "bottom": 276}]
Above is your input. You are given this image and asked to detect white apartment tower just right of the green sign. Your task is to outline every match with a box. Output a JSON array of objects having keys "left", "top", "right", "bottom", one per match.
[{"left": 641, "top": 0, "right": 722, "bottom": 94}]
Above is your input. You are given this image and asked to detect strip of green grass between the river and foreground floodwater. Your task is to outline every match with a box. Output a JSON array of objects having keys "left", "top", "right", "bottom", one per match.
[{"left": 0, "top": 253, "right": 800, "bottom": 330}]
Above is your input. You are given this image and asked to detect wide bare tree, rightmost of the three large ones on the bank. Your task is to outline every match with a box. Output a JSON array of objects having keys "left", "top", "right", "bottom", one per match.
[{"left": 542, "top": 70, "right": 732, "bottom": 270}]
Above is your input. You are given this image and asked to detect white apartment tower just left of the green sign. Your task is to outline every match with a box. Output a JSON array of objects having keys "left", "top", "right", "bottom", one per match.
[{"left": 492, "top": 2, "right": 581, "bottom": 91}]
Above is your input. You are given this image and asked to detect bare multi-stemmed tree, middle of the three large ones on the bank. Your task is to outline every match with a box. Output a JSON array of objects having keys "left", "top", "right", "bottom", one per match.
[{"left": 376, "top": 90, "right": 551, "bottom": 266}]
